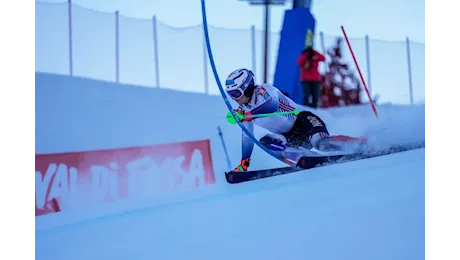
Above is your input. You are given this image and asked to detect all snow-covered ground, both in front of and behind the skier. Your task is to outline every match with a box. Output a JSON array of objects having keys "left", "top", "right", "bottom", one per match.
[{"left": 34, "top": 73, "right": 426, "bottom": 260}]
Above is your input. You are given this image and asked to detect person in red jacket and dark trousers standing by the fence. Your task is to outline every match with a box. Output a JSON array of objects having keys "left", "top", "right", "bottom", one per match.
[{"left": 297, "top": 46, "right": 326, "bottom": 108}]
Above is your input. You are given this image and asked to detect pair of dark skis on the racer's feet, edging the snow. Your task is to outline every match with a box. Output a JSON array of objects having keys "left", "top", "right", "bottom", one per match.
[{"left": 225, "top": 136, "right": 367, "bottom": 184}]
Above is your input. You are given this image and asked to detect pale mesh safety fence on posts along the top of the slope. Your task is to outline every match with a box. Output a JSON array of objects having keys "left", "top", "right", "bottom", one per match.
[{"left": 33, "top": 1, "right": 426, "bottom": 104}]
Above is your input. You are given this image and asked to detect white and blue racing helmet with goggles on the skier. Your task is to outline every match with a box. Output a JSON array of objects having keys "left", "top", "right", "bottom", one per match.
[{"left": 225, "top": 69, "right": 255, "bottom": 100}]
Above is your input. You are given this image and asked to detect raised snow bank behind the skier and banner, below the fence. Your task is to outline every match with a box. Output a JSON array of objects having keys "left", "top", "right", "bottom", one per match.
[{"left": 33, "top": 73, "right": 426, "bottom": 180}]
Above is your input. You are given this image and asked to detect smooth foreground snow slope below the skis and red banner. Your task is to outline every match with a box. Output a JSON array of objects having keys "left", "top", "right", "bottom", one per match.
[{"left": 35, "top": 149, "right": 426, "bottom": 260}]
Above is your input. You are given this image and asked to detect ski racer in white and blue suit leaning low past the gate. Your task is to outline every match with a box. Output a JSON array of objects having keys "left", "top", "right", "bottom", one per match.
[{"left": 225, "top": 68, "right": 340, "bottom": 172}]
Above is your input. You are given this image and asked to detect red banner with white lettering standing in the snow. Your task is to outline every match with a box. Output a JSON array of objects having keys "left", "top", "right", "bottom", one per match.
[{"left": 33, "top": 140, "right": 215, "bottom": 216}]
